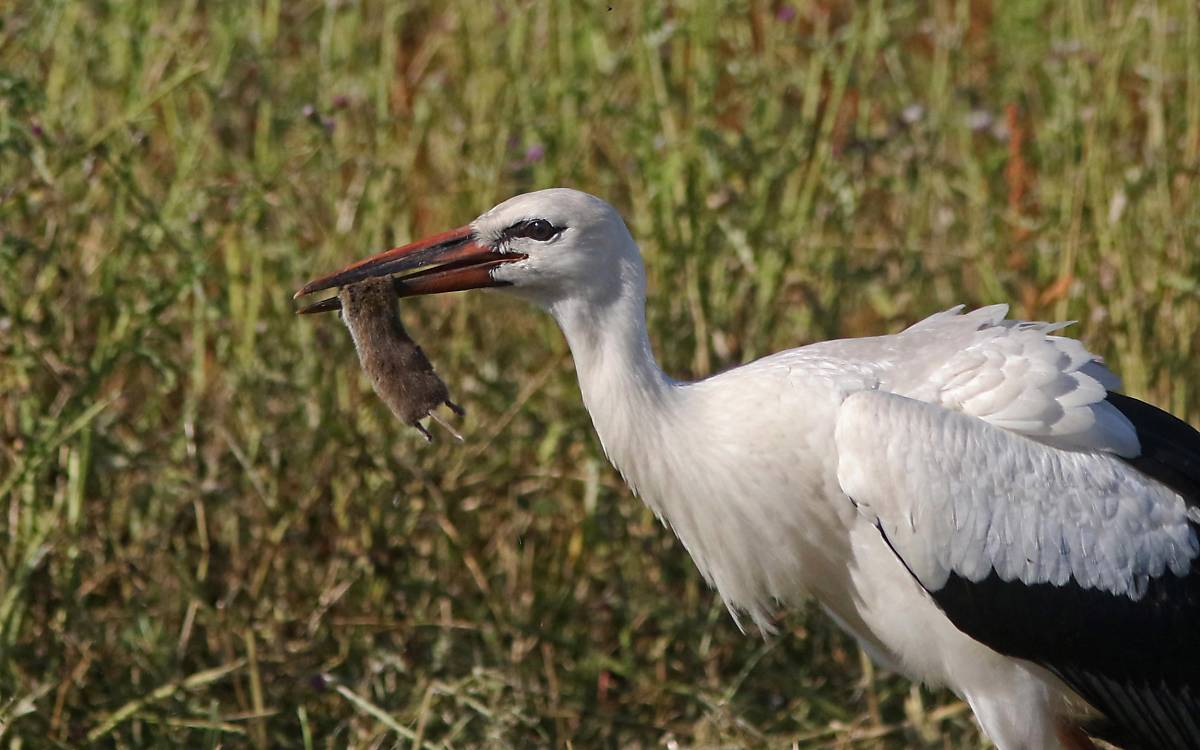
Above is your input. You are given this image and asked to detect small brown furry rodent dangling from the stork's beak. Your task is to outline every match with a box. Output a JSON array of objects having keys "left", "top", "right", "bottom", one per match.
[{"left": 337, "top": 277, "right": 462, "bottom": 438}]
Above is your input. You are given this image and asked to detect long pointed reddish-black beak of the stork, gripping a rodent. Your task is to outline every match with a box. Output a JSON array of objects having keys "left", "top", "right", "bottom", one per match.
[{"left": 293, "top": 227, "right": 524, "bottom": 314}]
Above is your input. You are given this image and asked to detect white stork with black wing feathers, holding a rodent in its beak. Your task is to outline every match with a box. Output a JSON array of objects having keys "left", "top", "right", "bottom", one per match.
[{"left": 296, "top": 188, "right": 1200, "bottom": 750}]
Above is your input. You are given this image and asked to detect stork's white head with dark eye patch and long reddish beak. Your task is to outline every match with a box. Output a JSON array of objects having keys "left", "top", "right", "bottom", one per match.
[{"left": 296, "top": 187, "right": 644, "bottom": 313}]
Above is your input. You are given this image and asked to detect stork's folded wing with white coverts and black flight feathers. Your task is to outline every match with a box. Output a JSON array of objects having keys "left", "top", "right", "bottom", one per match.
[{"left": 835, "top": 391, "right": 1200, "bottom": 748}]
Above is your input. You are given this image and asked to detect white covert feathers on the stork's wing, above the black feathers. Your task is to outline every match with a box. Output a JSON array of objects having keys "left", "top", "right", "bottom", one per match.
[{"left": 835, "top": 391, "right": 1200, "bottom": 599}]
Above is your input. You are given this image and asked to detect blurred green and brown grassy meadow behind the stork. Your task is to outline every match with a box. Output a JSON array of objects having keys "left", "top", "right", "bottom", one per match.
[{"left": 0, "top": 0, "right": 1200, "bottom": 750}]
